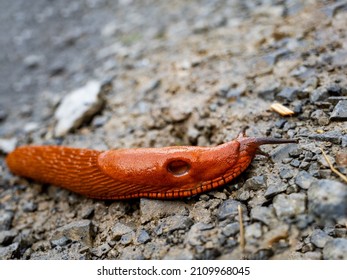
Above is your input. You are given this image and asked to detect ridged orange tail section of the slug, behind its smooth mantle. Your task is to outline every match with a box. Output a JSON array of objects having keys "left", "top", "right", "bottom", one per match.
[{"left": 6, "top": 146, "right": 121, "bottom": 197}]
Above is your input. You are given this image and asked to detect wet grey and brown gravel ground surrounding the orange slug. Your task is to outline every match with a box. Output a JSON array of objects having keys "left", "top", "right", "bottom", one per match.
[{"left": 0, "top": 0, "right": 347, "bottom": 259}]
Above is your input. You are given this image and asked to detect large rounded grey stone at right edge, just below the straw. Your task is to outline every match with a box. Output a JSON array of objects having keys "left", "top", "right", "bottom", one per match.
[{"left": 307, "top": 179, "right": 347, "bottom": 225}]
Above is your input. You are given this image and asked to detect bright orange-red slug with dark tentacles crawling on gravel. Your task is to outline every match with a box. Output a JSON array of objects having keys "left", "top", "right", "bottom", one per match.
[{"left": 6, "top": 132, "right": 296, "bottom": 199}]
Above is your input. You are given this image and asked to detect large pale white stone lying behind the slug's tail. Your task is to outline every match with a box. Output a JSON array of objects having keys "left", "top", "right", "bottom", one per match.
[{"left": 54, "top": 81, "right": 103, "bottom": 137}]
